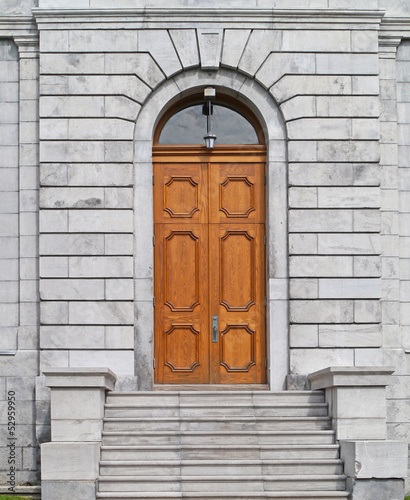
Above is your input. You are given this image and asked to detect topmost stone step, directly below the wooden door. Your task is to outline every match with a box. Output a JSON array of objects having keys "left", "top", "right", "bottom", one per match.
[{"left": 106, "top": 391, "right": 325, "bottom": 406}]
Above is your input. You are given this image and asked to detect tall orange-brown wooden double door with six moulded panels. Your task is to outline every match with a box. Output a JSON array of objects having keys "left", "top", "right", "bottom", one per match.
[{"left": 153, "top": 146, "right": 266, "bottom": 384}]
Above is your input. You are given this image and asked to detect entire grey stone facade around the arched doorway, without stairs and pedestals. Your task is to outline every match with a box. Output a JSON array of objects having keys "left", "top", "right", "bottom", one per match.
[{"left": 0, "top": 0, "right": 410, "bottom": 494}]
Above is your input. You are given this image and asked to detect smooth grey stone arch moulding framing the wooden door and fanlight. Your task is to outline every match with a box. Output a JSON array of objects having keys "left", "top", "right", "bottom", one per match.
[{"left": 134, "top": 69, "right": 289, "bottom": 390}]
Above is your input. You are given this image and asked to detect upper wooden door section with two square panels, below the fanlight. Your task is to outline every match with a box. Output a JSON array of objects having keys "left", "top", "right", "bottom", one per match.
[{"left": 154, "top": 157, "right": 265, "bottom": 224}]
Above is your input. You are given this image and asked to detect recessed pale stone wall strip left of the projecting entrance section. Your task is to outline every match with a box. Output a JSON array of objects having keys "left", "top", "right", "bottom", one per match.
[{"left": 0, "top": 36, "right": 41, "bottom": 484}]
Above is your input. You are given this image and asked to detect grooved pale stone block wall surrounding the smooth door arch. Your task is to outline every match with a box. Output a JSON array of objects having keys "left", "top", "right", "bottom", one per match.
[{"left": 34, "top": 19, "right": 382, "bottom": 383}]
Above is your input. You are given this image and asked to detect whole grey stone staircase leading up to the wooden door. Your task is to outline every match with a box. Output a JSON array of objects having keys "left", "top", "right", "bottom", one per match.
[{"left": 97, "top": 391, "right": 349, "bottom": 500}]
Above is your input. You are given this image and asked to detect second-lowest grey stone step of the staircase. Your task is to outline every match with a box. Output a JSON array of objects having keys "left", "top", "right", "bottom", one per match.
[{"left": 98, "top": 475, "right": 346, "bottom": 492}]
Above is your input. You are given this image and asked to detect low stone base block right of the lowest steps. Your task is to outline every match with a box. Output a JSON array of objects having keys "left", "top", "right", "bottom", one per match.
[{"left": 346, "top": 478, "right": 404, "bottom": 500}]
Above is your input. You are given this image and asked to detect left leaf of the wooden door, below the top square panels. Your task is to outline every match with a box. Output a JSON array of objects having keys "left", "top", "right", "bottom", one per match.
[{"left": 154, "top": 224, "right": 209, "bottom": 384}]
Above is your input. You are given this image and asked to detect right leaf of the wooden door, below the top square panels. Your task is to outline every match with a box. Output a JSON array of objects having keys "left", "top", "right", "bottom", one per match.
[{"left": 210, "top": 224, "right": 266, "bottom": 384}]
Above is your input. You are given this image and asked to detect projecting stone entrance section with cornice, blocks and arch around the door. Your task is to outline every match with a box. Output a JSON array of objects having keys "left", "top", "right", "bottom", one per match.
[{"left": 34, "top": 3, "right": 388, "bottom": 396}]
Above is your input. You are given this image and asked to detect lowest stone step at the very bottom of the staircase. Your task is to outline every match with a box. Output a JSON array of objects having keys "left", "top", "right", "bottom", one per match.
[{"left": 97, "top": 491, "right": 350, "bottom": 500}]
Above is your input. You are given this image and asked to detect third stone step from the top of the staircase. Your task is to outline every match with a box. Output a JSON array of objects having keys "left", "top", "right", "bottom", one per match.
[{"left": 104, "top": 417, "right": 331, "bottom": 431}]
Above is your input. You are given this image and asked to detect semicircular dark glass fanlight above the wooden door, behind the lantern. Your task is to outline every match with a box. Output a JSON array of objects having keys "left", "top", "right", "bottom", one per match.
[{"left": 158, "top": 104, "right": 259, "bottom": 144}]
